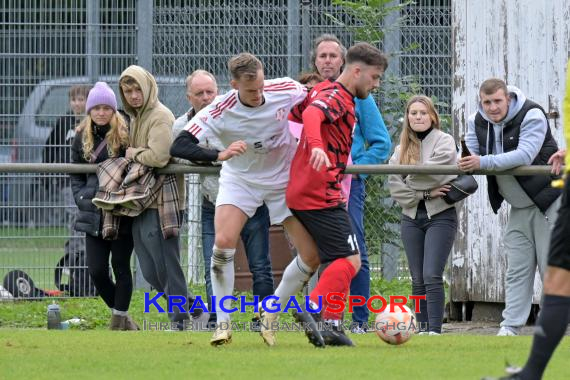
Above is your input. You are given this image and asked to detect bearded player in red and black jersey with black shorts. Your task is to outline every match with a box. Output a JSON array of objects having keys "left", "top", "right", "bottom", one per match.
[{"left": 286, "top": 43, "right": 387, "bottom": 346}]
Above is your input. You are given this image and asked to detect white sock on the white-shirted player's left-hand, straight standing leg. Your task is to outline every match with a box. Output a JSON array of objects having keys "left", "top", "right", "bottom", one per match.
[{"left": 210, "top": 245, "right": 236, "bottom": 323}]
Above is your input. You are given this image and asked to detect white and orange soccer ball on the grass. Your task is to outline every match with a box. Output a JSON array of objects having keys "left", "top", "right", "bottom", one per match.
[{"left": 374, "top": 304, "right": 416, "bottom": 345}]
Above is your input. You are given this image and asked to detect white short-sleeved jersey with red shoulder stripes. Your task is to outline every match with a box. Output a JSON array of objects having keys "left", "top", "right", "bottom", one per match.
[{"left": 185, "top": 78, "right": 306, "bottom": 189}]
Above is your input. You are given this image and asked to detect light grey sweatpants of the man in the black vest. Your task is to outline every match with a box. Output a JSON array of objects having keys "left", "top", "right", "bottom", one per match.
[{"left": 501, "top": 198, "right": 560, "bottom": 327}]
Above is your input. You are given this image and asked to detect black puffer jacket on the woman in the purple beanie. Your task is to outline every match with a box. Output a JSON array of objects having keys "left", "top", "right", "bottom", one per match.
[{"left": 70, "top": 125, "right": 132, "bottom": 237}]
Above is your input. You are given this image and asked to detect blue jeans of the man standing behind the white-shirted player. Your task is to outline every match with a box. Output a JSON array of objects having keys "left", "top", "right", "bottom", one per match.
[{"left": 202, "top": 198, "right": 274, "bottom": 320}]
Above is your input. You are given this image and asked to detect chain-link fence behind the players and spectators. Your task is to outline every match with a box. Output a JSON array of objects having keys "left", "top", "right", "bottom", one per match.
[{"left": 0, "top": 0, "right": 451, "bottom": 300}]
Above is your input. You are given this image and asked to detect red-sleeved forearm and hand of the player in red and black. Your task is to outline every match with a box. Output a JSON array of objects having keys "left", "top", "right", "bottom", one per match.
[{"left": 303, "top": 107, "right": 331, "bottom": 171}]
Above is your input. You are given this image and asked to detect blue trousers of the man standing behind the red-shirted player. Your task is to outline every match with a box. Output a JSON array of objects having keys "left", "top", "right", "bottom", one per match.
[{"left": 348, "top": 176, "right": 370, "bottom": 326}]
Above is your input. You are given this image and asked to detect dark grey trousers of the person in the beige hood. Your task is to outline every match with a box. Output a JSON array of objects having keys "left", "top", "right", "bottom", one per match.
[{"left": 133, "top": 209, "right": 190, "bottom": 322}]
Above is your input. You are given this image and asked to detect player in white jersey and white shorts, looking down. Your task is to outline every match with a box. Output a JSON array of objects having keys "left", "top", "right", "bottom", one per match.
[{"left": 170, "top": 53, "right": 319, "bottom": 346}]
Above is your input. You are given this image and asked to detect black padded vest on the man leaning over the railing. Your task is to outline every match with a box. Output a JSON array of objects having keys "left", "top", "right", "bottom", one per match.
[{"left": 475, "top": 99, "right": 562, "bottom": 214}]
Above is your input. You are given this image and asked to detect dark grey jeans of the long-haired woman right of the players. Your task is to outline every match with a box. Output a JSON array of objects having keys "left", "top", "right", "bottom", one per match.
[{"left": 402, "top": 207, "right": 457, "bottom": 333}]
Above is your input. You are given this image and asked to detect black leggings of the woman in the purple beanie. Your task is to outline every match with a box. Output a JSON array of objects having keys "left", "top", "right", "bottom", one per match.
[{"left": 85, "top": 234, "right": 133, "bottom": 311}]
